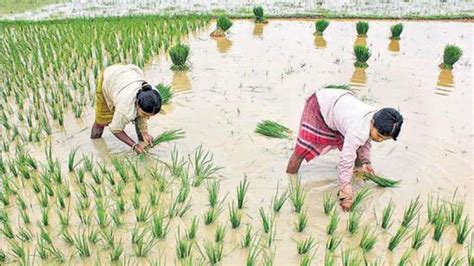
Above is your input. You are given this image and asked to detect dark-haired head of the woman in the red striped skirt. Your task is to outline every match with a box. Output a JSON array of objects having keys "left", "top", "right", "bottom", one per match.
[{"left": 374, "top": 108, "right": 403, "bottom": 140}]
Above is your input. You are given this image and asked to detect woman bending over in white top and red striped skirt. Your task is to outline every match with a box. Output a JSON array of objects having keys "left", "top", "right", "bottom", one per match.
[{"left": 286, "top": 88, "right": 403, "bottom": 211}]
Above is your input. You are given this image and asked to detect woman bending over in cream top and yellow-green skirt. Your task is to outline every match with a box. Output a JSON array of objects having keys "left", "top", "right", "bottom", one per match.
[{"left": 91, "top": 64, "right": 161, "bottom": 154}]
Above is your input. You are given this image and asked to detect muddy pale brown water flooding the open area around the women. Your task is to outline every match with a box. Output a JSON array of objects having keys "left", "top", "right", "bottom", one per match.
[{"left": 5, "top": 20, "right": 474, "bottom": 265}]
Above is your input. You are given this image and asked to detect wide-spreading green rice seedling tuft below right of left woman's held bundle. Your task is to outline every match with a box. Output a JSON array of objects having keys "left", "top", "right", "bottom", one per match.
[{"left": 190, "top": 145, "right": 222, "bottom": 187}]
